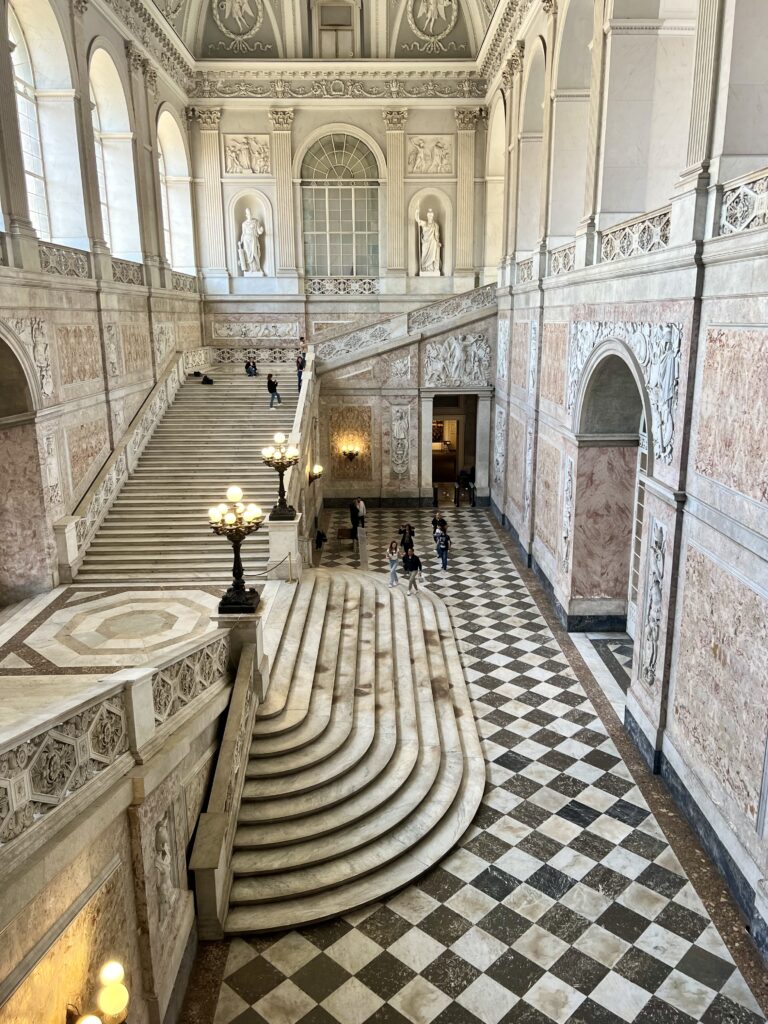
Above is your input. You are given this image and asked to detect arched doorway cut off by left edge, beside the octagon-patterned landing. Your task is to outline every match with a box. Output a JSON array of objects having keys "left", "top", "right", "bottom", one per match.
[{"left": 0, "top": 338, "right": 54, "bottom": 607}]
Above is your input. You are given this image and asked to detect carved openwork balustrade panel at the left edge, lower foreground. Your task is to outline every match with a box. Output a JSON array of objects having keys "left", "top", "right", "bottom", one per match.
[{"left": 0, "top": 693, "right": 128, "bottom": 847}]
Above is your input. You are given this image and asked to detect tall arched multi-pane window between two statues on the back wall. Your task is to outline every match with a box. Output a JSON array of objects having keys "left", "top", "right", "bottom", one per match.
[{"left": 301, "top": 134, "right": 379, "bottom": 278}]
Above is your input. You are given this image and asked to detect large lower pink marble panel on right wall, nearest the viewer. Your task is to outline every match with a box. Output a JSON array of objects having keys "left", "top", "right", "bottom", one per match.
[{"left": 674, "top": 547, "right": 768, "bottom": 821}]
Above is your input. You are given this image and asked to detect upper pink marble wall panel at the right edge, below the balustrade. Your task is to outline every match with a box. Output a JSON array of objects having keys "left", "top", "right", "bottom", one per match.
[{"left": 695, "top": 329, "right": 768, "bottom": 504}]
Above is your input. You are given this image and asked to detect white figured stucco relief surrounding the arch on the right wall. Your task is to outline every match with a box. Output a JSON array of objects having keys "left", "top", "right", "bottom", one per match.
[{"left": 567, "top": 321, "right": 683, "bottom": 464}]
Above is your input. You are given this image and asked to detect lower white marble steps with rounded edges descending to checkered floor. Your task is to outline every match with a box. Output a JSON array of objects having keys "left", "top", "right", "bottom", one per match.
[{"left": 225, "top": 569, "right": 485, "bottom": 934}]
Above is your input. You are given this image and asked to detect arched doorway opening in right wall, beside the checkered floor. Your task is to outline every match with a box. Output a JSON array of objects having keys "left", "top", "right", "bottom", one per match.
[{"left": 569, "top": 350, "right": 648, "bottom": 636}]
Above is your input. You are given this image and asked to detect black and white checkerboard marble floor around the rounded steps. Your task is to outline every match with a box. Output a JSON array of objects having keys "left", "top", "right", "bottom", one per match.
[{"left": 201, "top": 510, "right": 766, "bottom": 1024}]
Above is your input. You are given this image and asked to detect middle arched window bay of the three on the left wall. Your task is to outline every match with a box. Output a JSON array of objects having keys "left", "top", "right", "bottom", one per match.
[{"left": 89, "top": 46, "right": 142, "bottom": 262}]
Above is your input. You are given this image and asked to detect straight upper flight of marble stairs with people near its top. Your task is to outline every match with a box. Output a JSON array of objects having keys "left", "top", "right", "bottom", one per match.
[{"left": 77, "top": 364, "right": 298, "bottom": 585}]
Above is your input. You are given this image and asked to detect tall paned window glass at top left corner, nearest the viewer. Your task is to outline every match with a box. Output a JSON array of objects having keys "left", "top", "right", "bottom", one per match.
[{"left": 8, "top": 7, "right": 50, "bottom": 242}]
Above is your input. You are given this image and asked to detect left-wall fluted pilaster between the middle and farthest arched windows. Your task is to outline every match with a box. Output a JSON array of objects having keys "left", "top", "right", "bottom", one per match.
[{"left": 125, "top": 41, "right": 163, "bottom": 288}]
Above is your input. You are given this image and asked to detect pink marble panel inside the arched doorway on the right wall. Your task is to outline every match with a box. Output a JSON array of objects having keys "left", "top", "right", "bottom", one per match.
[{"left": 570, "top": 447, "right": 637, "bottom": 600}]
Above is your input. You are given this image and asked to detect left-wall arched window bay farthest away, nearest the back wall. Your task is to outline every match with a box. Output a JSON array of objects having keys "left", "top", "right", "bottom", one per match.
[{"left": 158, "top": 110, "right": 196, "bottom": 273}]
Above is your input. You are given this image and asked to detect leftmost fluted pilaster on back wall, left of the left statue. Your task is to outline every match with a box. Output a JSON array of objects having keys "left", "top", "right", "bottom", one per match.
[{"left": 186, "top": 106, "right": 229, "bottom": 294}]
